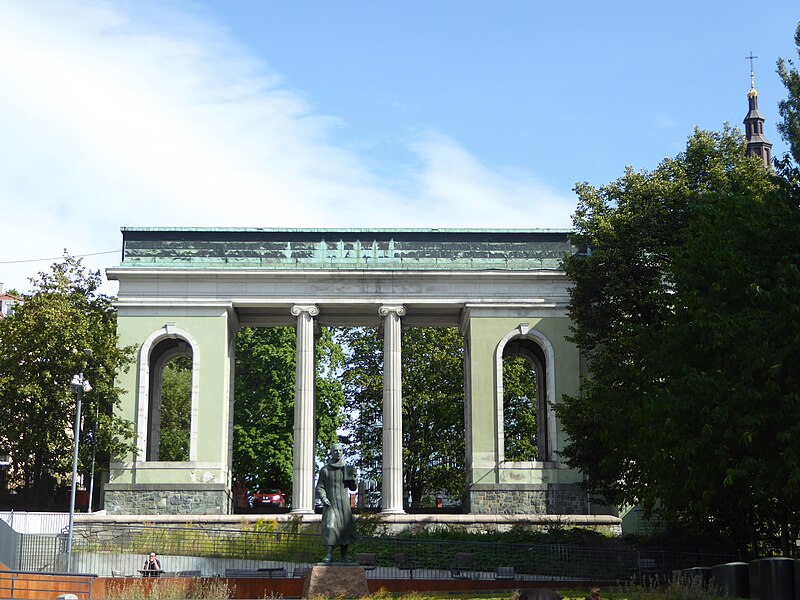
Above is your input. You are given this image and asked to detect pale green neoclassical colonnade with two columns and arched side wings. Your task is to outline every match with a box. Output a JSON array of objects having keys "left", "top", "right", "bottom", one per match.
[{"left": 105, "top": 228, "right": 590, "bottom": 514}]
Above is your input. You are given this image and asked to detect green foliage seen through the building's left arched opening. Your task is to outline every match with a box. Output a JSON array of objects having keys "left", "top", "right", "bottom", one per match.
[{"left": 158, "top": 356, "right": 192, "bottom": 462}]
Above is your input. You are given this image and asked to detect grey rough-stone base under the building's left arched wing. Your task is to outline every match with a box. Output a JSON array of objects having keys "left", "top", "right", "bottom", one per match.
[{"left": 104, "top": 483, "right": 231, "bottom": 515}]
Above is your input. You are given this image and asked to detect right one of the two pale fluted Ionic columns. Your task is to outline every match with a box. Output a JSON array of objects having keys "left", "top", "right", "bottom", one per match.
[{"left": 378, "top": 305, "right": 406, "bottom": 514}]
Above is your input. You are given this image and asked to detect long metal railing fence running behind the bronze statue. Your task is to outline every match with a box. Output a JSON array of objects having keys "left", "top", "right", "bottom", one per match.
[{"left": 12, "top": 523, "right": 739, "bottom": 581}]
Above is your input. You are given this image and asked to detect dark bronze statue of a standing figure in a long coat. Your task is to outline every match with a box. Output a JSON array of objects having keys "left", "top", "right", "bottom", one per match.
[{"left": 316, "top": 444, "right": 356, "bottom": 562}]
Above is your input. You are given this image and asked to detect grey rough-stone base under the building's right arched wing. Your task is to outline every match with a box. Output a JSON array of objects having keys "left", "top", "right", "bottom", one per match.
[{"left": 467, "top": 483, "right": 589, "bottom": 515}]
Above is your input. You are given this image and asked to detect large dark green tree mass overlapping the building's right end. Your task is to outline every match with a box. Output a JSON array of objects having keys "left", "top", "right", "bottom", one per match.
[{"left": 556, "top": 122, "right": 800, "bottom": 550}]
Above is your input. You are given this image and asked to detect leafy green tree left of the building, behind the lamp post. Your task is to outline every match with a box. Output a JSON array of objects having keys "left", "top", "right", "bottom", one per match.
[{"left": 0, "top": 253, "right": 134, "bottom": 506}]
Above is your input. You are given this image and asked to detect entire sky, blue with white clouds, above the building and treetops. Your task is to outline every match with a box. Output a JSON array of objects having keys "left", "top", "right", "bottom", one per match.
[{"left": 0, "top": 0, "right": 800, "bottom": 292}]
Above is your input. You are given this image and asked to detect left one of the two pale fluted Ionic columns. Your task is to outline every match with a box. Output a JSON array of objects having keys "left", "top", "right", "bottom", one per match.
[{"left": 292, "top": 304, "right": 319, "bottom": 513}]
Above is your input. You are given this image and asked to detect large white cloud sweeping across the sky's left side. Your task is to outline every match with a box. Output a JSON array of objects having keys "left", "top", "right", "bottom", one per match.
[{"left": 0, "top": 1, "right": 574, "bottom": 288}]
